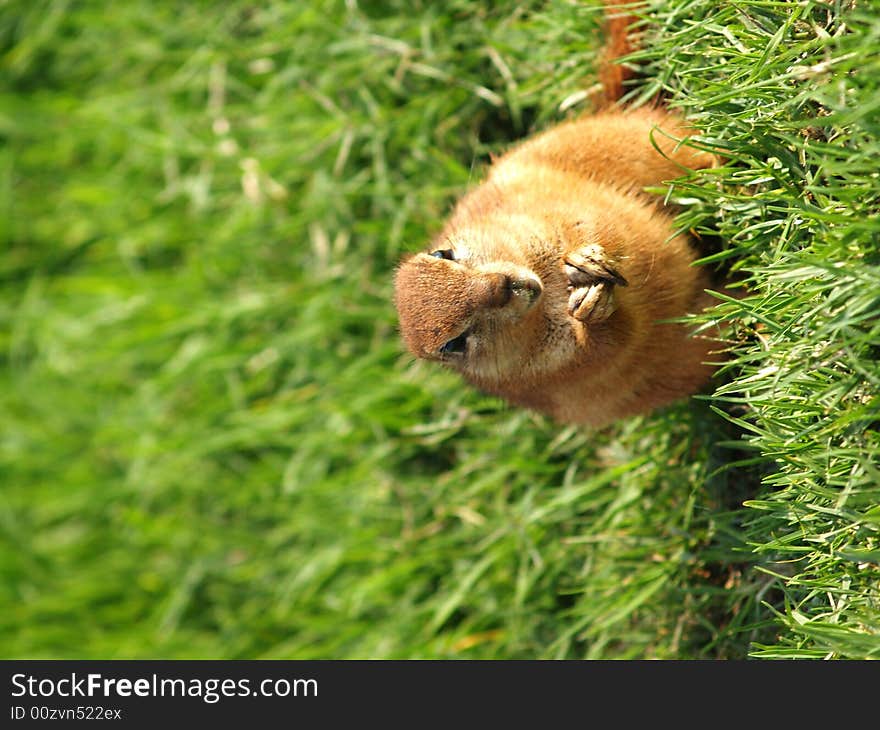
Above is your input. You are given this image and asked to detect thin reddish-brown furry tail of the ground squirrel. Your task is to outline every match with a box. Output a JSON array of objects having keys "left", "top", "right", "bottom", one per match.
[{"left": 594, "top": 0, "right": 644, "bottom": 108}]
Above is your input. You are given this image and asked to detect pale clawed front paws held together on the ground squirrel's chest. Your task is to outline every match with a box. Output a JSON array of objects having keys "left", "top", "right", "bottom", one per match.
[{"left": 564, "top": 244, "right": 626, "bottom": 322}]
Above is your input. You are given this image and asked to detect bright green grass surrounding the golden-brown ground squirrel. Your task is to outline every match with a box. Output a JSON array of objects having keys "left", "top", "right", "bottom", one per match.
[{"left": 0, "top": 0, "right": 880, "bottom": 658}]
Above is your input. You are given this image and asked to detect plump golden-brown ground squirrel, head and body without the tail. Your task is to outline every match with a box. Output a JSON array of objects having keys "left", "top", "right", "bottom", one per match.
[{"left": 395, "top": 14, "right": 716, "bottom": 427}]
